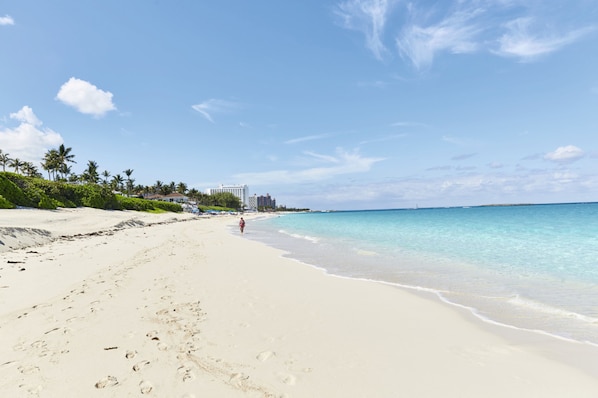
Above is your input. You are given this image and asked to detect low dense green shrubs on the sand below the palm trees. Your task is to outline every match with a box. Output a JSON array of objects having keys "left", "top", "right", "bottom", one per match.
[{"left": 0, "top": 172, "right": 183, "bottom": 212}]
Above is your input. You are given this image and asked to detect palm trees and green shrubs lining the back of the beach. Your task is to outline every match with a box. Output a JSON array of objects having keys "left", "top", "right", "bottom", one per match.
[{"left": 0, "top": 144, "right": 293, "bottom": 212}]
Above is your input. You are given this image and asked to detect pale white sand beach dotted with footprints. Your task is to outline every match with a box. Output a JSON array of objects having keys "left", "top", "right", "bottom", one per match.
[{"left": 0, "top": 208, "right": 598, "bottom": 398}]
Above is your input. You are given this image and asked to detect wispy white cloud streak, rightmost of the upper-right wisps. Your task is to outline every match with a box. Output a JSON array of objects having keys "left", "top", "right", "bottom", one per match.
[{"left": 496, "top": 18, "right": 593, "bottom": 61}]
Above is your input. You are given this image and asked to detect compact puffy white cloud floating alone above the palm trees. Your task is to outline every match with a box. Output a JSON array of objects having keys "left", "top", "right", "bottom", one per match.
[{"left": 56, "top": 77, "right": 116, "bottom": 117}]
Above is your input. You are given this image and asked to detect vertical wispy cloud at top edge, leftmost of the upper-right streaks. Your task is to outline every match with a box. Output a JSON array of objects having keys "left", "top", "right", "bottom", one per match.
[{"left": 336, "top": 0, "right": 396, "bottom": 59}]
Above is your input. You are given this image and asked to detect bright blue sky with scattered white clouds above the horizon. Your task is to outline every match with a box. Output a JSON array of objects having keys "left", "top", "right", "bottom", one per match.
[{"left": 0, "top": 0, "right": 598, "bottom": 210}]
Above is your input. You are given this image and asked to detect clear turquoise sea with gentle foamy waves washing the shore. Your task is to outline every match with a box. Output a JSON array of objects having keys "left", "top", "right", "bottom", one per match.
[{"left": 246, "top": 203, "right": 598, "bottom": 344}]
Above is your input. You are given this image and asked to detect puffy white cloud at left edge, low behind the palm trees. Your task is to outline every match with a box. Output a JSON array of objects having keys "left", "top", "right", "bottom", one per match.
[{"left": 0, "top": 106, "right": 64, "bottom": 162}]
